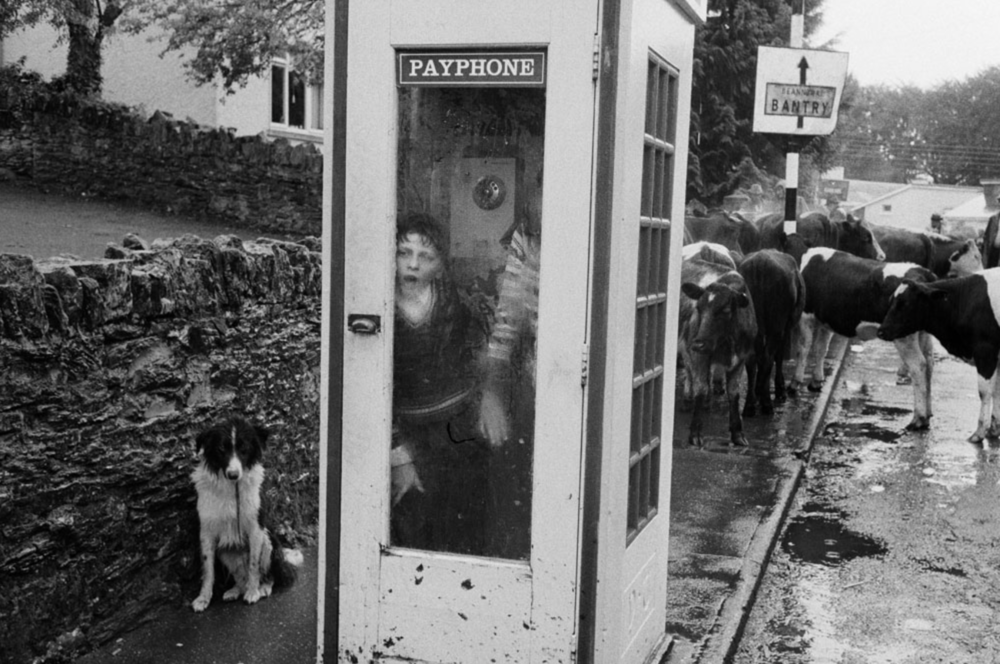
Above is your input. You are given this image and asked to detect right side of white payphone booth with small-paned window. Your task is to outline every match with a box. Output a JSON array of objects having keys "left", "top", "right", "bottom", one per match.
[{"left": 599, "top": 0, "right": 693, "bottom": 662}]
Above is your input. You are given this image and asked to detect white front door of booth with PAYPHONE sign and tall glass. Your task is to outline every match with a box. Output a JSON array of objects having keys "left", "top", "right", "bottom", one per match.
[{"left": 336, "top": 2, "right": 594, "bottom": 663}]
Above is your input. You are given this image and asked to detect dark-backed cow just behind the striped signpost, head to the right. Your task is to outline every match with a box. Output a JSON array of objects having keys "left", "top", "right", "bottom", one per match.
[{"left": 757, "top": 212, "right": 885, "bottom": 261}]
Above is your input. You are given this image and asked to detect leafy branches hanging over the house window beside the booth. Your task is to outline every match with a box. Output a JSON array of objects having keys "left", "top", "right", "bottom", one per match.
[{"left": 125, "top": 0, "right": 325, "bottom": 92}]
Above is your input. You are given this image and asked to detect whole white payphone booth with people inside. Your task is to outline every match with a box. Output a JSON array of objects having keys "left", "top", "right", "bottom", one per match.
[{"left": 319, "top": 0, "right": 705, "bottom": 664}]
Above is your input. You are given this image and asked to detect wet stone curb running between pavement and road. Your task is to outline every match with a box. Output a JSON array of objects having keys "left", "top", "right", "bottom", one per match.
[{"left": 695, "top": 336, "right": 851, "bottom": 664}]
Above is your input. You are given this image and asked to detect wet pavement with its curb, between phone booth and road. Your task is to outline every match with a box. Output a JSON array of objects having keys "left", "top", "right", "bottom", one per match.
[{"left": 663, "top": 337, "right": 848, "bottom": 664}]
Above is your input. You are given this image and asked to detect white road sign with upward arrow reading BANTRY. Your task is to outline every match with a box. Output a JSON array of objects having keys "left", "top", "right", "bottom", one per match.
[{"left": 753, "top": 46, "right": 847, "bottom": 136}]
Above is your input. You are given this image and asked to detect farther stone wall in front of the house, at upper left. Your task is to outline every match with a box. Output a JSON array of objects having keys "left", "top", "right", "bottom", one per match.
[{"left": 0, "top": 85, "right": 323, "bottom": 236}]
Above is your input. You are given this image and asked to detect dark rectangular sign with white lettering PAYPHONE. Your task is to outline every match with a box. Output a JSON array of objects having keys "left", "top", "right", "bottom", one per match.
[{"left": 396, "top": 51, "right": 545, "bottom": 87}]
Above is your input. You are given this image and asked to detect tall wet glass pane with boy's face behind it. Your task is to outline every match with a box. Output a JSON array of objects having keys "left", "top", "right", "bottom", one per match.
[{"left": 390, "top": 55, "right": 545, "bottom": 560}]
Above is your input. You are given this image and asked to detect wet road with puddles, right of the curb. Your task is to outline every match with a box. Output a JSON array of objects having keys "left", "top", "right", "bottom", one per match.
[{"left": 734, "top": 341, "right": 1000, "bottom": 664}]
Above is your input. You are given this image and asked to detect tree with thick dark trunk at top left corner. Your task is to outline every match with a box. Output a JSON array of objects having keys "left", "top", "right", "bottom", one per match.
[{"left": 0, "top": 0, "right": 127, "bottom": 96}]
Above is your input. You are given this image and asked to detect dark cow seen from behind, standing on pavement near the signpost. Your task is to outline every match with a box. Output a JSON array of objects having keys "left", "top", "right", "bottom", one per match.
[{"left": 738, "top": 249, "right": 806, "bottom": 417}]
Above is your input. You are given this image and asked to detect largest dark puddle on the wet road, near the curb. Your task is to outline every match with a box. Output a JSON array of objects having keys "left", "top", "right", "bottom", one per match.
[{"left": 781, "top": 512, "right": 887, "bottom": 567}]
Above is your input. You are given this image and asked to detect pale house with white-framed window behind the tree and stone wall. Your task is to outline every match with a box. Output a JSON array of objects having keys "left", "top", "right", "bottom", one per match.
[{"left": 0, "top": 23, "right": 323, "bottom": 143}]
